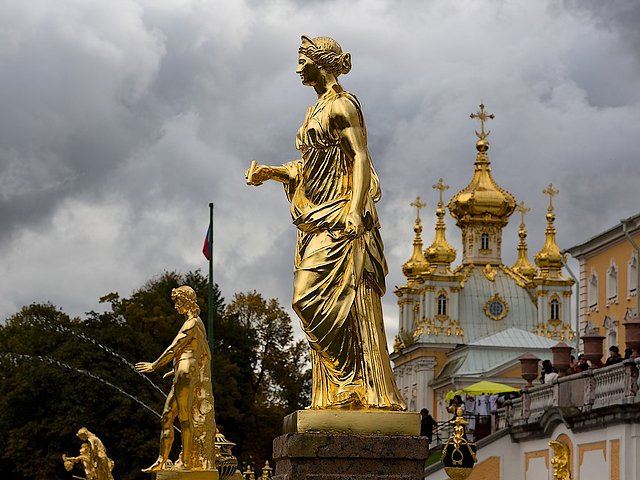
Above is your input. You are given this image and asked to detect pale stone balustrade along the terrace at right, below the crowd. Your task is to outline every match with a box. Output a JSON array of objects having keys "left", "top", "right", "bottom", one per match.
[{"left": 492, "top": 358, "right": 640, "bottom": 432}]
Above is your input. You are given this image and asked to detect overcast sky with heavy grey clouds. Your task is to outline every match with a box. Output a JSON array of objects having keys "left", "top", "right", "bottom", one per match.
[{"left": 0, "top": 0, "right": 640, "bottom": 341}]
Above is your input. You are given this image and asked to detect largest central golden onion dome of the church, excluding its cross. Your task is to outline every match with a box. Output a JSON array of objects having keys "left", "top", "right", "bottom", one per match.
[{"left": 448, "top": 136, "right": 516, "bottom": 225}]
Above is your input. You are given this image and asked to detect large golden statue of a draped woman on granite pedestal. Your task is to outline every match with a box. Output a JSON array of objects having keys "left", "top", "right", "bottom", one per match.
[{"left": 246, "top": 36, "right": 406, "bottom": 410}]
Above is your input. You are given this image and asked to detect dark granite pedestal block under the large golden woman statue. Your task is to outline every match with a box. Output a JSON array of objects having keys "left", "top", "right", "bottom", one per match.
[{"left": 273, "top": 433, "right": 429, "bottom": 480}]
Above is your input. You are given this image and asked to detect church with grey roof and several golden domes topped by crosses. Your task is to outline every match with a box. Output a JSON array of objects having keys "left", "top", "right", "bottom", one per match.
[{"left": 392, "top": 104, "right": 574, "bottom": 420}]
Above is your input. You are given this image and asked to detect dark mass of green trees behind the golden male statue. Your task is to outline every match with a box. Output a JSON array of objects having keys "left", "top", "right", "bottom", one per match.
[{"left": 0, "top": 271, "right": 310, "bottom": 480}]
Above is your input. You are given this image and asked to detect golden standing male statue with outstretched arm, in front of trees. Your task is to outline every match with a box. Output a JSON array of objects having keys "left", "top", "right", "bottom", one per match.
[{"left": 136, "top": 286, "right": 218, "bottom": 479}]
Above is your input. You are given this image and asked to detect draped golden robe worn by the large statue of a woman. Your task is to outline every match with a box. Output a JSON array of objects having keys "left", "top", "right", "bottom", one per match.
[{"left": 284, "top": 90, "right": 406, "bottom": 410}]
